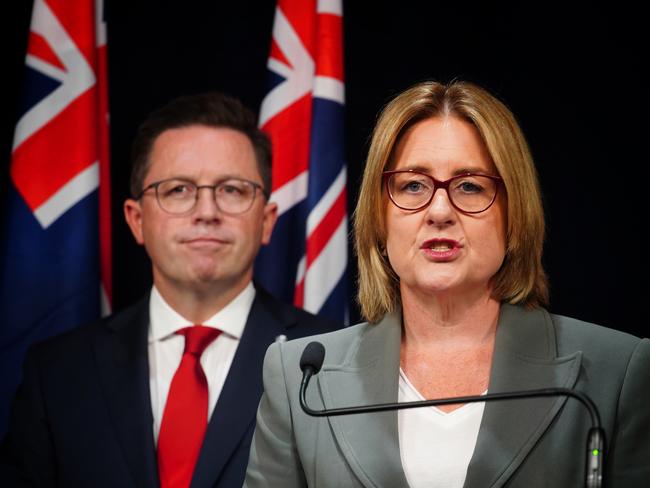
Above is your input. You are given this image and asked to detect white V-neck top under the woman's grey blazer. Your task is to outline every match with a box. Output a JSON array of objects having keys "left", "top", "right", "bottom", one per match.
[{"left": 397, "top": 368, "right": 485, "bottom": 488}]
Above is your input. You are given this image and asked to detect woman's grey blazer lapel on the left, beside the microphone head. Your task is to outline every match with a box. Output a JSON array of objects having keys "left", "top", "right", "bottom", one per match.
[{"left": 316, "top": 313, "right": 408, "bottom": 487}]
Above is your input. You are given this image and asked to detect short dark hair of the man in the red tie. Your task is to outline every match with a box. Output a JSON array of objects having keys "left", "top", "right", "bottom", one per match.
[{"left": 130, "top": 92, "right": 271, "bottom": 198}]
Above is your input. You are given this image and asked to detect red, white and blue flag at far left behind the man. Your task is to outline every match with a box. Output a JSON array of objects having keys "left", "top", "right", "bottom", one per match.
[{"left": 0, "top": 0, "right": 111, "bottom": 434}]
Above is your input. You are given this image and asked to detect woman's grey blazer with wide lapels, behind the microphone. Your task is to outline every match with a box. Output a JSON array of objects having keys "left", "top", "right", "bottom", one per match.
[{"left": 244, "top": 305, "right": 650, "bottom": 488}]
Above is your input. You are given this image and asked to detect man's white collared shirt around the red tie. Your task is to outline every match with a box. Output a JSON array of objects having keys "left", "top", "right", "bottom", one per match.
[{"left": 149, "top": 283, "right": 255, "bottom": 445}]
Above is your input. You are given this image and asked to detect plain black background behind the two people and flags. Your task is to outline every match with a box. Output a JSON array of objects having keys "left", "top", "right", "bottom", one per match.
[{"left": 0, "top": 0, "right": 650, "bottom": 336}]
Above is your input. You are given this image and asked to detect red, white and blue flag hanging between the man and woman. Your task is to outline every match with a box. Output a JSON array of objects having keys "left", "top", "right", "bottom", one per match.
[{"left": 255, "top": 0, "right": 348, "bottom": 322}]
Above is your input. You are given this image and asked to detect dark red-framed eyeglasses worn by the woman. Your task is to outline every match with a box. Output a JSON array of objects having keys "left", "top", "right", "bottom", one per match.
[{"left": 383, "top": 170, "right": 503, "bottom": 214}]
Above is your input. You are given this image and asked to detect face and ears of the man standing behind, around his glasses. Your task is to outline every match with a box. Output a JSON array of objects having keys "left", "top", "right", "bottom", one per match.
[{"left": 124, "top": 125, "right": 277, "bottom": 294}]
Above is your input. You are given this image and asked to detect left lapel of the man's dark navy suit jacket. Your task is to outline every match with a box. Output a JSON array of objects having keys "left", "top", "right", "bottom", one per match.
[{"left": 93, "top": 297, "right": 158, "bottom": 488}]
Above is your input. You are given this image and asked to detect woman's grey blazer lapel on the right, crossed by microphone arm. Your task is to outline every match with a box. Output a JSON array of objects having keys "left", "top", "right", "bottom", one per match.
[{"left": 464, "top": 305, "right": 581, "bottom": 488}]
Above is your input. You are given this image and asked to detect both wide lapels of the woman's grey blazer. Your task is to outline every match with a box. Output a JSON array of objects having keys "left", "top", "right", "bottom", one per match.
[{"left": 317, "top": 305, "right": 581, "bottom": 487}]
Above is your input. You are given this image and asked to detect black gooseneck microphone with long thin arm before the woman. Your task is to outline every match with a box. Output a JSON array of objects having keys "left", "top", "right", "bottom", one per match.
[{"left": 300, "top": 341, "right": 605, "bottom": 488}]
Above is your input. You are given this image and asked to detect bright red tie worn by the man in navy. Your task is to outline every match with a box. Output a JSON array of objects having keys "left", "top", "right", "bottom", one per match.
[{"left": 158, "top": 325, "right": 221, "bottom": 488}]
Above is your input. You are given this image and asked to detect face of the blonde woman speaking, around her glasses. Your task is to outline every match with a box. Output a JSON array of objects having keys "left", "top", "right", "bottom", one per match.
[{"left": 386, "top": 116, "right": 506, "bottom": 297}]
